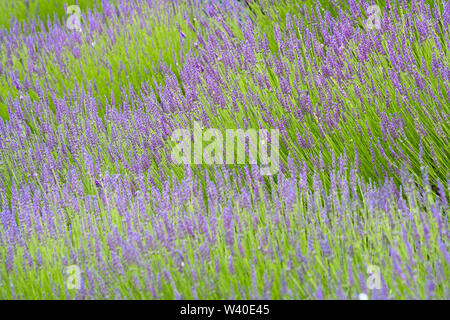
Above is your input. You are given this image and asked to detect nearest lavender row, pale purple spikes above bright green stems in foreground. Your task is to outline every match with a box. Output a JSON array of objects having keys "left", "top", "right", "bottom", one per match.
[{"left": 1, "top": 151, "right": 450, "bottom": 299}]
